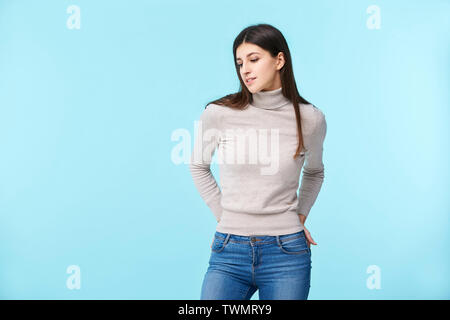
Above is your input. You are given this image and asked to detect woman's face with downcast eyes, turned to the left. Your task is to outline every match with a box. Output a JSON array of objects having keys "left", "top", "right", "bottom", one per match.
[{"left": 236, "top": 42, "right": 285, "bottom": 93}]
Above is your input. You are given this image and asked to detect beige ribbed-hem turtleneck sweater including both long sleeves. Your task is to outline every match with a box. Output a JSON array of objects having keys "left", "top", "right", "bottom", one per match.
[{"left": 190, "top": 88, "right": 327, "bottom": 236}]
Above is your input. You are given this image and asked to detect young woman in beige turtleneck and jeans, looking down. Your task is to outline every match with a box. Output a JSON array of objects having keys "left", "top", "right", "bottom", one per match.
[{"left": 190, "top": 24, "right": 326, "bottom": 300}]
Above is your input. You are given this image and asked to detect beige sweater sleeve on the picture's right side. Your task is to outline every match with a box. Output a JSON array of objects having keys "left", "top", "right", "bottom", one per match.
[{"left": 297, "top": 108, "right": 327, "bottom": 216}]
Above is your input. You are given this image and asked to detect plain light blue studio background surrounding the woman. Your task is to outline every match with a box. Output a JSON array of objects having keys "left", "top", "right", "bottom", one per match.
[{"left": 0, "top": 0, "right": 450, "bottom": 299}]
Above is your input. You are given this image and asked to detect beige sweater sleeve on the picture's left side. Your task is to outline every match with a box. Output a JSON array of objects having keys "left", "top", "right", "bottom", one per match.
[{"left": 190, "top": 105, "right": 222, "bottom": 222}]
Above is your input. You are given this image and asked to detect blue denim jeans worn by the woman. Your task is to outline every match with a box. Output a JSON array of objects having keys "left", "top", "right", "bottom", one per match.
[{"left": 200, "top": 230, "right": 311, "bottom": 300}]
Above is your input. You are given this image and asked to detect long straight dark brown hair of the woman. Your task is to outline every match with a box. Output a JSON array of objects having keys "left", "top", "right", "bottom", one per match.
[{"left": 205, "top": 24, "right": 310, "bottom": 159}]
